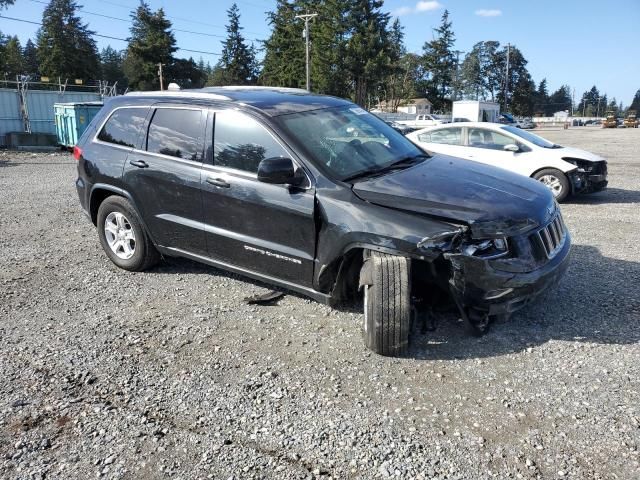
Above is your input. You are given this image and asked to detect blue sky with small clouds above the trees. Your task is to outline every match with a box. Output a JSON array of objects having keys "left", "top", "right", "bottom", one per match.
[{"left": 0, "top": 0, "right": 640, "bottom": 105}]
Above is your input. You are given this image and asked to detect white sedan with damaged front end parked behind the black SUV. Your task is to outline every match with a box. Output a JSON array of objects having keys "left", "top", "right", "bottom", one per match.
[{"left": 407, "top": 122, "right": 607, "bottom": 202}]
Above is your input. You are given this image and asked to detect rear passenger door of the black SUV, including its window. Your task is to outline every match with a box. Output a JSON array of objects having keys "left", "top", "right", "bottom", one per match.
[{"left": 123, "top": 104, "right": 207, "bottom": 254}]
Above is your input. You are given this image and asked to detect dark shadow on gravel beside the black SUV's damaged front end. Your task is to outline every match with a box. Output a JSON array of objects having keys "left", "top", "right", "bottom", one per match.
[{"left": 409, "top": 245, "right": 640, "bottom": 360}]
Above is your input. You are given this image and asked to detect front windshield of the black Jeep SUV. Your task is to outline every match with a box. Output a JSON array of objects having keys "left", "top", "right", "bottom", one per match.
[{"left": 278, "top": 105, "right": 425, "bottom": 180}]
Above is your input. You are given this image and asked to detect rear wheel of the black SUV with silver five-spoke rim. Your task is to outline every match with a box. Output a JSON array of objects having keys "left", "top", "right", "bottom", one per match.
[{"left": 97, "top": 195, "right": 160, "bottom": 272}]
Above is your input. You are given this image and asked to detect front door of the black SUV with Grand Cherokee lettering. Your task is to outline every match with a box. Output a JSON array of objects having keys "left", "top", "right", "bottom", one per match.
[{"left": 202, "top": 110, "right": 316, "bottom": 286}]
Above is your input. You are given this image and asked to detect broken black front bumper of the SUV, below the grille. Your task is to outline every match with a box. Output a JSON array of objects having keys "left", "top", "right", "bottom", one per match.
[{"left": 450, "top": 233, "right": 571, "bottom": 315}]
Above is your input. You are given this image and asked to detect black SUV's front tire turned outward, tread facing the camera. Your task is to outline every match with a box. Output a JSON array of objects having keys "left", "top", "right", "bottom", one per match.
[{"left": 360, "top": 252, "right": 411, "bottom": 356}]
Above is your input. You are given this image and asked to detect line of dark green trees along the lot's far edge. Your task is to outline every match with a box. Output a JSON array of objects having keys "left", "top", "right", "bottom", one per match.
[{"left": 0, "top": 0, "right": 640, "bottom": 116}]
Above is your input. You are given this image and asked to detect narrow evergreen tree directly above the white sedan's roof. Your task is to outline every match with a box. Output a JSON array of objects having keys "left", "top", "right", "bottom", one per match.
[{"left": 422, "top": 10, "right": 456, "bottom": 111}]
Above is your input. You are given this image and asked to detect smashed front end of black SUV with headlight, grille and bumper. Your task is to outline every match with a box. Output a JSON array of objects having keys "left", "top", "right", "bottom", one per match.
[{"left": 417, "top": 208, "right": 571, "bottom": 334}]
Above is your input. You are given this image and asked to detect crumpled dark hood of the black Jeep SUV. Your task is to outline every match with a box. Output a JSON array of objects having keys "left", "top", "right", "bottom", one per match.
[{"left": 353, "top": 155, "right": 556, "bottom": 238}]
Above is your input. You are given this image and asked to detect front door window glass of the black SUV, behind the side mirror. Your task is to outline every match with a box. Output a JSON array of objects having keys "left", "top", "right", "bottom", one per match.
[{"left": 213, "top": 111, "right": 289, "bottom": 173}]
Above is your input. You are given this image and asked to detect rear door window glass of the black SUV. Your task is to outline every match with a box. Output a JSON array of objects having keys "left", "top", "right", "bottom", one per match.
[{"left": 147, "top": 108, "right": 204, "bottom": 162}]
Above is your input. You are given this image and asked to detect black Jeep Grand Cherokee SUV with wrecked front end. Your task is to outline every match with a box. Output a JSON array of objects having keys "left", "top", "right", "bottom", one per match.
[{"left": 74, "top": 87, "right": 570, "bottom": 355}]
